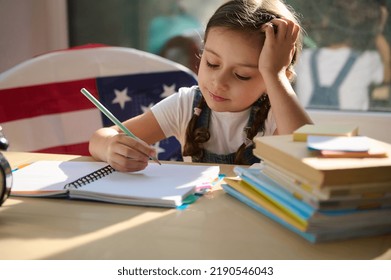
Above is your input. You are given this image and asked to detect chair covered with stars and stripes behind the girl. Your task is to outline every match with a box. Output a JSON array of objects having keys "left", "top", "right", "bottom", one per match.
[{"left": 0, "top": 45, "right": 197, "bottom": 160}]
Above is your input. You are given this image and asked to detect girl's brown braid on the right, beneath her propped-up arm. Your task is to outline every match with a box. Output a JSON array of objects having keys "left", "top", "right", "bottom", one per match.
[{"left": 235, "top": 94, "right": 271, "bottom": 164}]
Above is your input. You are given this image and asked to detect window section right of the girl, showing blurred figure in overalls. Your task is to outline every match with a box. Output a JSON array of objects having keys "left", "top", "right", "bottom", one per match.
[{"left": 287, "top": 0, "right": 391, "bottom": 142}]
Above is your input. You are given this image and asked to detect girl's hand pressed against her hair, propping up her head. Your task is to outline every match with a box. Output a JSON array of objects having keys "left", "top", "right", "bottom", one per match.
[{"left": 258, "top": 18, "right": 300, "bottom": 79}]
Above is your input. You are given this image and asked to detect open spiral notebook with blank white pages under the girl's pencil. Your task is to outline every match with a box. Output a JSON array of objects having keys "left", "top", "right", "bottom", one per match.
[{"left": 11, "top": 161, "right": 219, "bottom": 207}]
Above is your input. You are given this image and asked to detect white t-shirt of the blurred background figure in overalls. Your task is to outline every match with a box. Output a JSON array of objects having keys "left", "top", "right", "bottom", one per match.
[{"left": 295, "top": 48, "right": 384, "bottom": 110}]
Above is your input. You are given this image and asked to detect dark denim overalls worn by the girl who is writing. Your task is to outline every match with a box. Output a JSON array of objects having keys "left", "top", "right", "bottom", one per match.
[{"left": 192, "top": 89, "right": 261, "bottom": 164}]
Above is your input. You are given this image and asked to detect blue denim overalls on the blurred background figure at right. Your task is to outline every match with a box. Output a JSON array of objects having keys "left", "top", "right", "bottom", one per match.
[{"left": 308, "top": 50, "right": 357, "bottom": 109}]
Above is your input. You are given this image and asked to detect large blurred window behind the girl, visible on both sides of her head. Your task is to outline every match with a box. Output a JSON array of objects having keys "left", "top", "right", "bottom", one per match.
[{"left": 68, "top": 0, "right": 391, "bottom": 142}]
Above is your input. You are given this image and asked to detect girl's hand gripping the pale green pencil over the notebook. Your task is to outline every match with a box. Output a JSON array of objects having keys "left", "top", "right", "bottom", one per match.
[{"left": 106, "top": 133, "right": 156, "bottom": 172}]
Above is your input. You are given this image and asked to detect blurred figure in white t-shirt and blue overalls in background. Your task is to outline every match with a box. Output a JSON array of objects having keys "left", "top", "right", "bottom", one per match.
[{"left": 293, "top": 0, "right": 390, "bottom": 110}]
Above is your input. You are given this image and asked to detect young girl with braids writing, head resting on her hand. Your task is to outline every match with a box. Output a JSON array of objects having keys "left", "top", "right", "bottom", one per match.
[{"left": 90, "top": 0, "right": 311, "bottom": 171}]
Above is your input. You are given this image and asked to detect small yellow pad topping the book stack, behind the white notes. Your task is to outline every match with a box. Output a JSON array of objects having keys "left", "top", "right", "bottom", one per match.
[{"left": 293, "top": 124, "right": 358, "bottom": 142}]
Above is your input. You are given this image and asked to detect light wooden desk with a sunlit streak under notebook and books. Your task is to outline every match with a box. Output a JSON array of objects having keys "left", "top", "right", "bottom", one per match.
[{"left": 0, "top": 152, "right": 391, "bottom": 260}]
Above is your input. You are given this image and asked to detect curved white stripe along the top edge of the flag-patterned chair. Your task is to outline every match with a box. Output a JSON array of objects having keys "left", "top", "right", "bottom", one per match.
[{"left": 0, "top": 47, "right": 197, "bottom": 89}]
